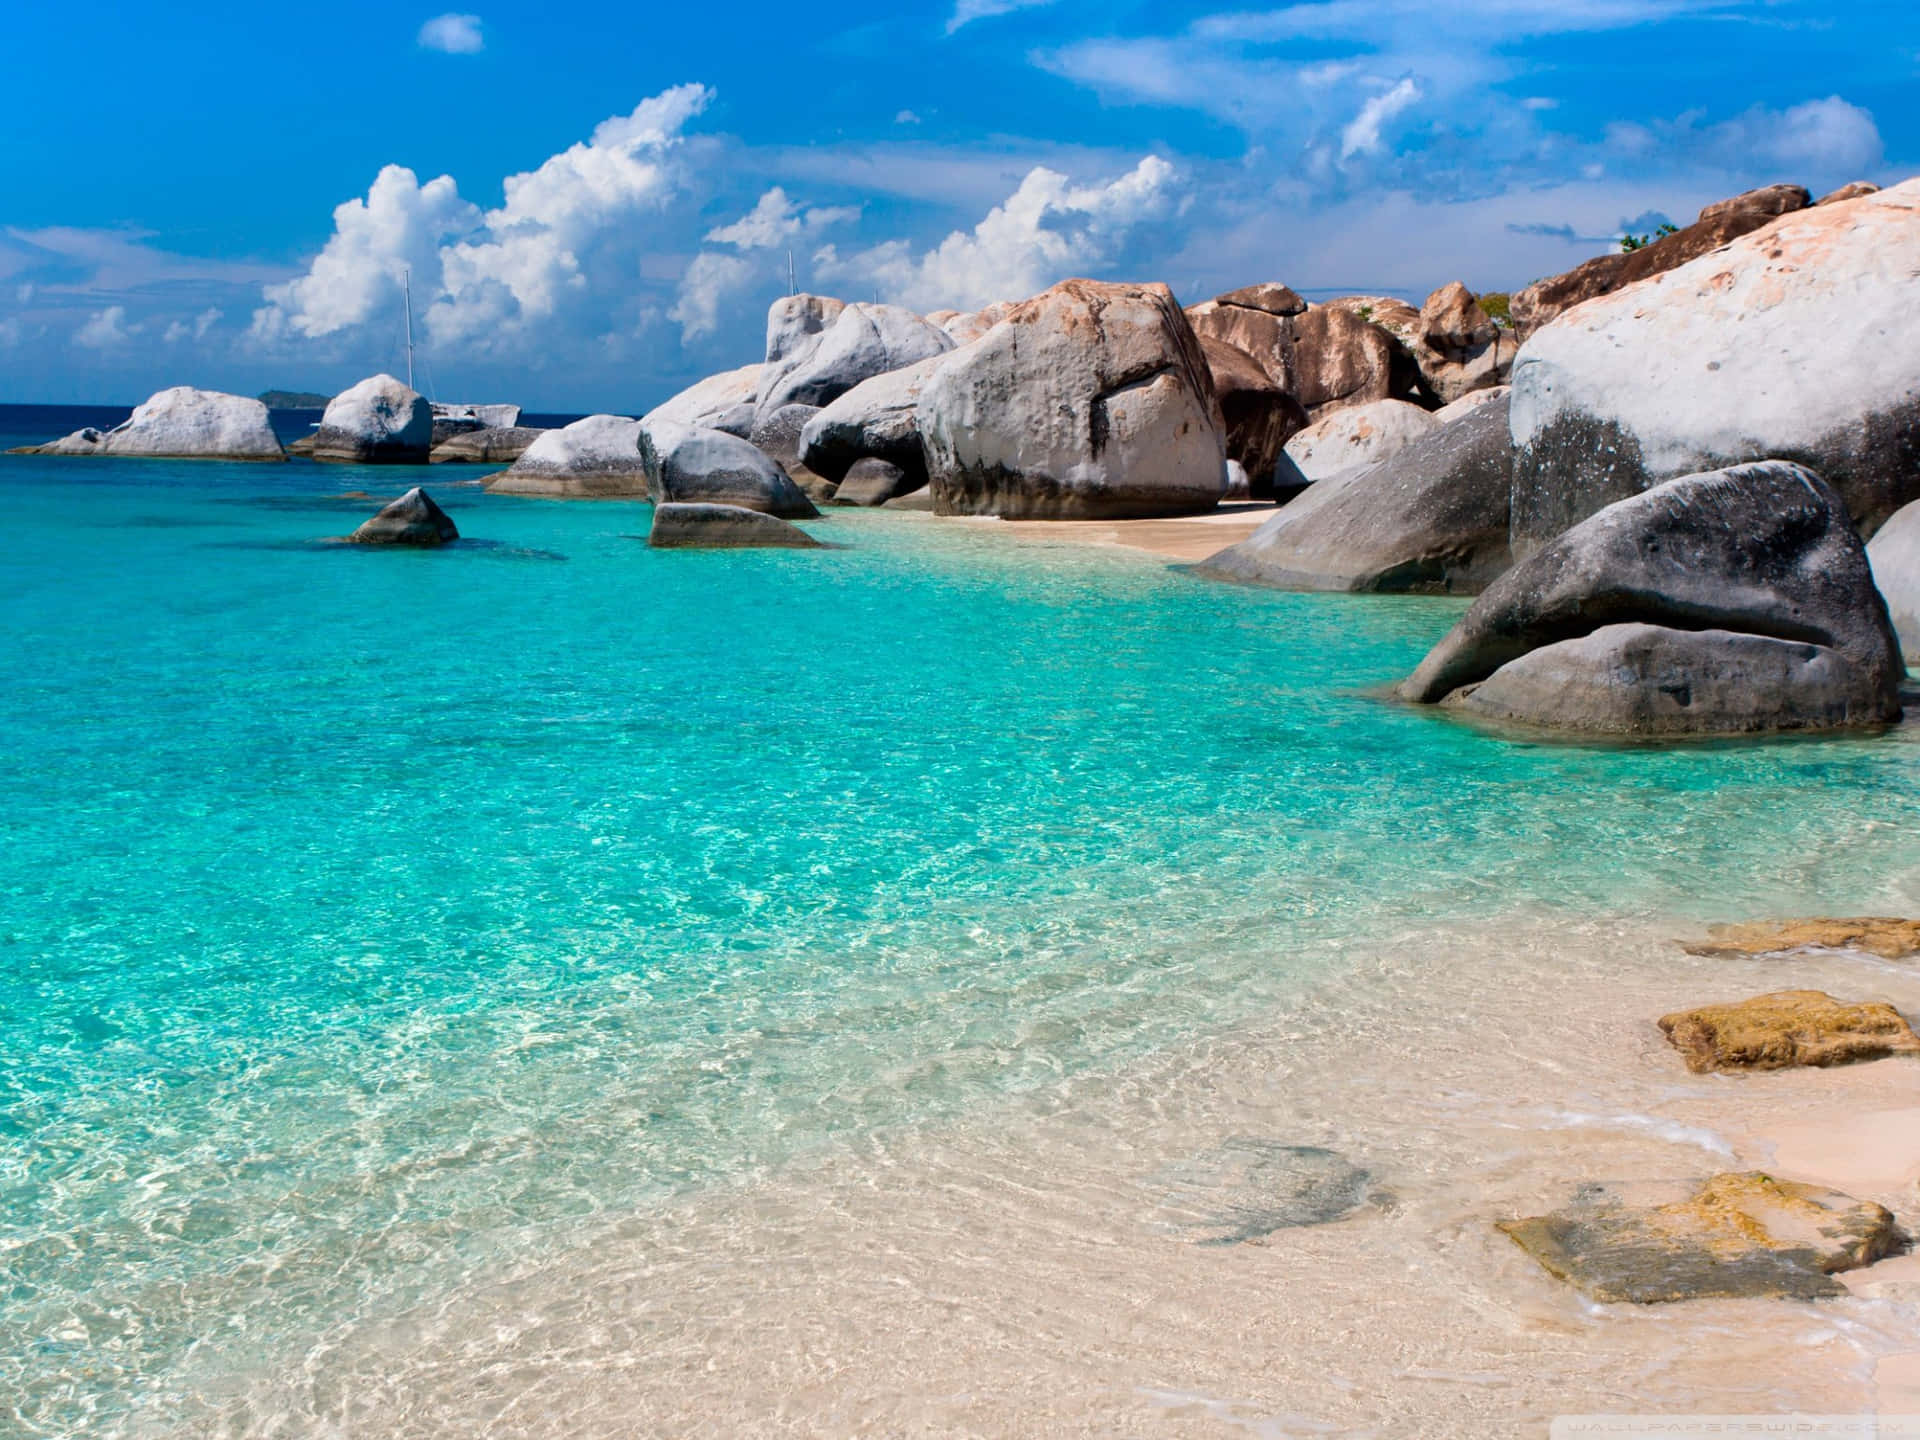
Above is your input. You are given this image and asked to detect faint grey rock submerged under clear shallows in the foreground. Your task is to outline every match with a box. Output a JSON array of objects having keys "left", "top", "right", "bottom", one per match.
[{"left": 1150, "top": 1137, "right": 1373, "bottom": 1244}]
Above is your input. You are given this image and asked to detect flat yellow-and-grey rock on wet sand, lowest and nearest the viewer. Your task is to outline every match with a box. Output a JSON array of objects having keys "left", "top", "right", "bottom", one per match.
[{"left": 1498, "top": 1173, "right": 1899, "bottom": 1306}]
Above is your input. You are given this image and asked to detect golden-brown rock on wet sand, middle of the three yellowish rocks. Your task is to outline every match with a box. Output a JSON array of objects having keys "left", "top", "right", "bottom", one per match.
[{"left": 1661, "top": 991, "right": 1920, "bottom": 1075}]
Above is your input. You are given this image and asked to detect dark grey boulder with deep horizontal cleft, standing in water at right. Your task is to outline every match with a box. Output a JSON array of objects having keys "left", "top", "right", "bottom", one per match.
[{"left": 1402, "top": 461, "right": 1905, "bottom": 735}]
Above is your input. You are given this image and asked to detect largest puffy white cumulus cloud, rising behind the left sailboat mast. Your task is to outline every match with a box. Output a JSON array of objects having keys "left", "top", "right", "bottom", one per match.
[{"left": 253, "top": 84, "right": 712, "bottom": 357}]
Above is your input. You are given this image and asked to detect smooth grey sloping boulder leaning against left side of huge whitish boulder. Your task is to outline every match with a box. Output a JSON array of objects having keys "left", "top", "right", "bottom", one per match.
[{"left": 1194, "top": 399, "right": 1513, "bottom": 595}]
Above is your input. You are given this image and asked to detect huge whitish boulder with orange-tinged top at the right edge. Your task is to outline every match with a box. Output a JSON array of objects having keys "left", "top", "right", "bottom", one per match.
[{"left": 1513, "top": 180, "right": 1920, "bottom": 553}]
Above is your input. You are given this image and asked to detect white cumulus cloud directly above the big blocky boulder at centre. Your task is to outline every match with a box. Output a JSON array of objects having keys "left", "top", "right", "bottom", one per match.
[{"left": 814, "top": 156, "right": 1185, "bottom": 309}]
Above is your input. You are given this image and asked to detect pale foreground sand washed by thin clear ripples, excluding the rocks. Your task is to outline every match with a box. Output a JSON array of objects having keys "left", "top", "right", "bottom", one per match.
[{"left": 191, "top": 916, "right": 1920, "bottom": 1440}]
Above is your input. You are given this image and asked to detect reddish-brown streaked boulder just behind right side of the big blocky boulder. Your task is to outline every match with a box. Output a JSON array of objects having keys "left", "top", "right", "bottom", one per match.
[{"left": 1187, "top": 284, "right": 1419, "bottom": 420}]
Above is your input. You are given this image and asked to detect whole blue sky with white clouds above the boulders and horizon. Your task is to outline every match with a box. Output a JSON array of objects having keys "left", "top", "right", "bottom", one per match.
[{"left": 0, "top": 0, "right": 1920, "bottom": 413}]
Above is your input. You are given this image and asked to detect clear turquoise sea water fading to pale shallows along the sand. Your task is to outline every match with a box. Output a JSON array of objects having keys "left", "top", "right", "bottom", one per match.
[{"left": 0, "top": 436, "right": 1920, "bottom": 1432}]
